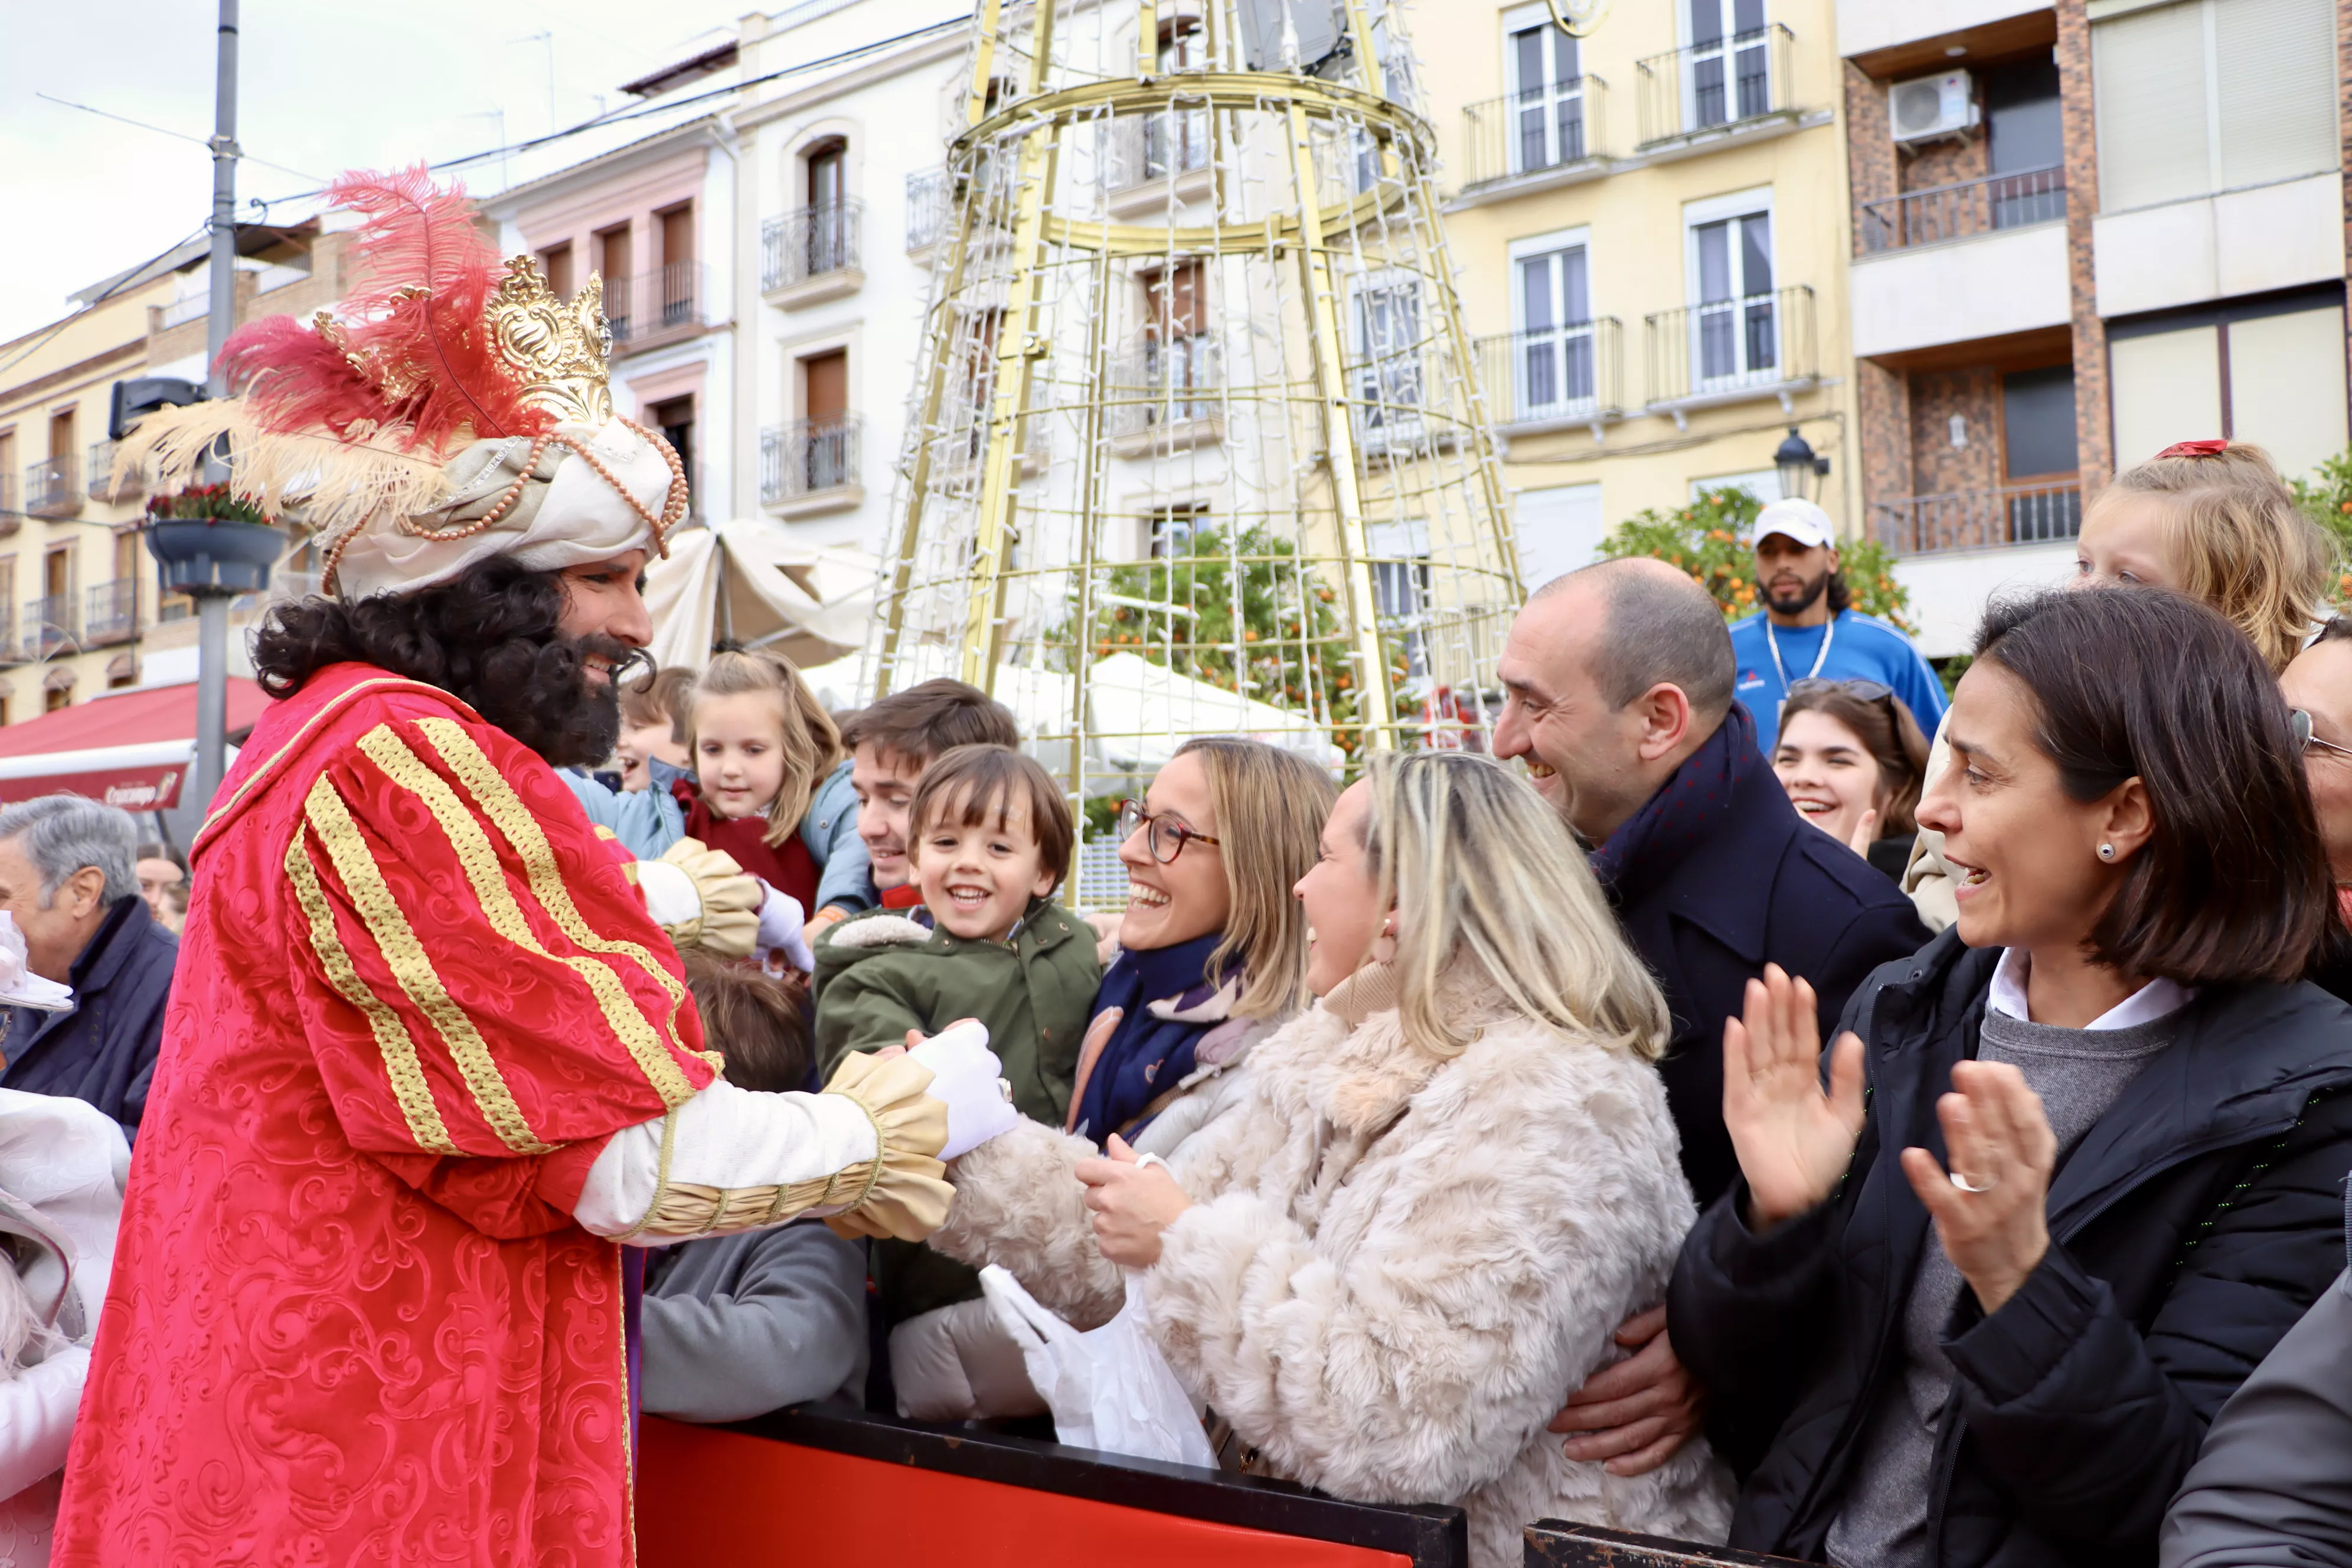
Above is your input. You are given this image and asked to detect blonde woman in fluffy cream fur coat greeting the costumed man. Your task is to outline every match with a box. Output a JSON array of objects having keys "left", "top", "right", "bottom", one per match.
[{"left": 934, "top": 752, "right": 1731, "bottom": 1568}]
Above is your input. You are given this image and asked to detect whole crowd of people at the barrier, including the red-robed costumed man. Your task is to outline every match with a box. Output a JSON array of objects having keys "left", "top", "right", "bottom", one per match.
[{"left": 0, "top": 174, "right": 2352, "bottom": 1568}]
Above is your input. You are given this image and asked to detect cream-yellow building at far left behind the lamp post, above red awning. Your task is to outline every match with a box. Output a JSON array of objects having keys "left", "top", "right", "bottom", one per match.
[{"left": 0, "top": 223, "right": 344, "bottom": 724}]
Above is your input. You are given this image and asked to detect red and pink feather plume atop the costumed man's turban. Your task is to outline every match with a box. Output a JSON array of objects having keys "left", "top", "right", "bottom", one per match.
[{"left": 221, "top": 165, "right": 555, "bottom": 452}]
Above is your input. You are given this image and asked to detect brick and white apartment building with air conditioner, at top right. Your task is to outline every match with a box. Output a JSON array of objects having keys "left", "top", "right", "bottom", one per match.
[{"left": 1837, "top": 0, "right": 2352, "bottom": 656}]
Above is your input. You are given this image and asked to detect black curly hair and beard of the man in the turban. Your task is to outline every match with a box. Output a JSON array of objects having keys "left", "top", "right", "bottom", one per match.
[{"left": 254, "top": 555, "right": 645, "bottom": 766}]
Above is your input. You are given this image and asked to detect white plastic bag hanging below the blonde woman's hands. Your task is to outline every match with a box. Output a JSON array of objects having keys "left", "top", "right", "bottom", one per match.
[{"left": 981, "top": 1265, "right": 1216, "bottom": 1469}]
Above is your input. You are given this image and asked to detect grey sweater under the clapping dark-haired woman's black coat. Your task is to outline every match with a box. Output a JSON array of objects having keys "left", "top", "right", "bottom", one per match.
[{"left": 1825, "top": 1008, "right": 2180, "bottom": 1568}]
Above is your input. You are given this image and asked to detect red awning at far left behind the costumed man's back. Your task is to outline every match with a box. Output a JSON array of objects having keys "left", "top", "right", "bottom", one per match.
[{"left": 0, "top": 677, "right": 270, "bottom": 811}]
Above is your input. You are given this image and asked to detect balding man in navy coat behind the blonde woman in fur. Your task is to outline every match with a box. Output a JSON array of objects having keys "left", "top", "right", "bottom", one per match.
[{"left": 1494, "top": 560, "right": 1929, "bottom": 1474}]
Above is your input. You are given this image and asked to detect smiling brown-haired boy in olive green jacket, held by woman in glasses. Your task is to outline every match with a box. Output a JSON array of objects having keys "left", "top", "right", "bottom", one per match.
[{"left": 816, "top": 745, "right": 1103, "bottom": 1420}]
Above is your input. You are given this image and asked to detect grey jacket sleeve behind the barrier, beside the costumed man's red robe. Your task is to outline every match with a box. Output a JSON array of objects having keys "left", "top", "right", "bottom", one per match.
[{"left": 645, "top": 1223, "right": 868, "bottom": 1422}]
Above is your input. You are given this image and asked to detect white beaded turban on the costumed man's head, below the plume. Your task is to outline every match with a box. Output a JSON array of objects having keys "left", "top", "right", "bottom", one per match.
[{"left": 334, "top": 419, "right": 675, "bottom": 599}]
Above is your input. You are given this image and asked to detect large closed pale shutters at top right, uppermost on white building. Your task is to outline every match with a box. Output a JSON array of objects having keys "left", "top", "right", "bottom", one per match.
[{"left": 2091, "top": 0, "right": 2343, "bottom": 211}]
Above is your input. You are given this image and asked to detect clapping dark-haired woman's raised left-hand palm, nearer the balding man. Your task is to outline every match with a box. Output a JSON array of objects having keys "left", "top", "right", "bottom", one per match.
[{"left": 1724, "top": 964, "right": 1863, "bottom": 1234}]
